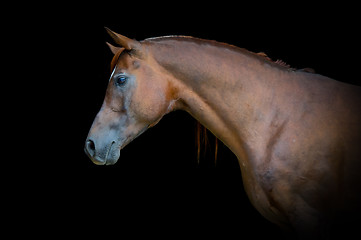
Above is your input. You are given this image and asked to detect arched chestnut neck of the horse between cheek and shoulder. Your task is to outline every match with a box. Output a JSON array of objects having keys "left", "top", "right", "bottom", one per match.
[{"left": 148, "top": 39, "right": 292, "bottom": 159}]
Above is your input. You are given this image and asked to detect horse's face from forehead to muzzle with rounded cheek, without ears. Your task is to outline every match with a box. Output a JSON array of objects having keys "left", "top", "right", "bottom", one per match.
[{"left": 85, "top": 37, "right": 170, "bottom": 165}]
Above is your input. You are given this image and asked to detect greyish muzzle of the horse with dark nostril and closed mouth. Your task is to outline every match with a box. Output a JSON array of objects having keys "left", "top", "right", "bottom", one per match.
[{"left": 84, "top": 138, "right": 120, "bottom": 165}]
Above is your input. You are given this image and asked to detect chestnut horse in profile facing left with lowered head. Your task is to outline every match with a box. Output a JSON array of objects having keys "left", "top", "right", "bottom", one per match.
[{"left": 85, "top": 28, "right": 361, "bottom": 239}]
